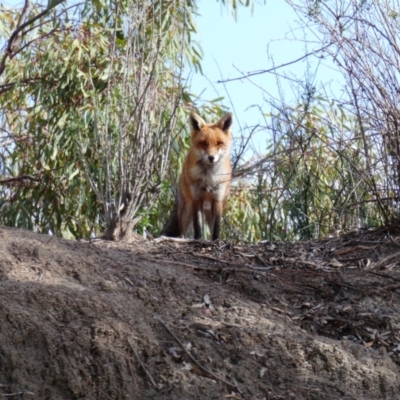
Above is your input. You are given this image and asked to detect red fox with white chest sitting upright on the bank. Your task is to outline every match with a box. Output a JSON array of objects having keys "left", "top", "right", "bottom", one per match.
[{"left": 162, "top": 112, "right": 232, "bottom": 240}]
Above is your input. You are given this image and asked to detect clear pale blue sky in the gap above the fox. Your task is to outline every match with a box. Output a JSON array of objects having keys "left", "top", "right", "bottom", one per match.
[{"left": 191, "top": 0, "right": 343, "bottom": 151}]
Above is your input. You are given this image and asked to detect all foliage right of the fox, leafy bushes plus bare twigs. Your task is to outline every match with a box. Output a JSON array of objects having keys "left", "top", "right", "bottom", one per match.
[{"left": 220, "top": 0, "right": 400, "bottom": 240}]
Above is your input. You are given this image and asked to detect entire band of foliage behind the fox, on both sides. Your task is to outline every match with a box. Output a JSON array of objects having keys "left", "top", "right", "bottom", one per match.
[{"left": 0, "top": 0, "right": 400, "bottom": 241}]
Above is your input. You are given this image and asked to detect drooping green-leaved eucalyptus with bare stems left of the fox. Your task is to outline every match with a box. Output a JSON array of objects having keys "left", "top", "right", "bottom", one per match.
[{"left": 0, "top": 0, "right": 253, "bottom": 239}]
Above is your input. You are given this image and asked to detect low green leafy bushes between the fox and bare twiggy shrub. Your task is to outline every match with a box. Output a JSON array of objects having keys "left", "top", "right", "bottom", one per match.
[{"left": 226, "top": 99, "right": 382, "bottom": 241}]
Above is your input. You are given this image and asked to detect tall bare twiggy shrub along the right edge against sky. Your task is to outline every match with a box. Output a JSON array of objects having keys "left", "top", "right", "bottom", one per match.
[{"left": 287, "top": 0, "right": 400, "bottom": 224}]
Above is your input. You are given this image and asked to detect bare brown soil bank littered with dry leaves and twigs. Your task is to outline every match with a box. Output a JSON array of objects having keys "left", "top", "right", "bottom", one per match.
[{"left": 0, "top": 227, "right": 400, "bottom": 400}]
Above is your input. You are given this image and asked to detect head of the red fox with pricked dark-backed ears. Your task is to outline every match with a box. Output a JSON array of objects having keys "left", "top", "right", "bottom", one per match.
[{"left": 189, "top": 112, "right": 232, "bottom": 165}]
